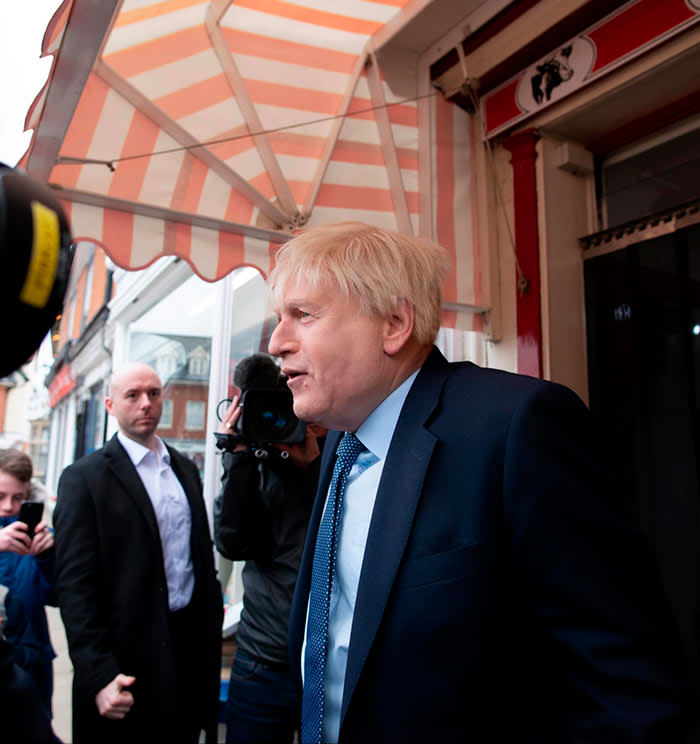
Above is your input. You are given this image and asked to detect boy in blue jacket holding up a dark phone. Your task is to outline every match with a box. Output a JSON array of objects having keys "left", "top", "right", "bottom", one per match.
[{"left": 0, "top": 449, "right": 56, "bottom": 715}]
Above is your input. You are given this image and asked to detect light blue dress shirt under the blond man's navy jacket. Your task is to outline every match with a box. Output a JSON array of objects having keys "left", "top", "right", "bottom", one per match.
[{"left": 301, "top": 372, "right": 418, "bottom": 743}]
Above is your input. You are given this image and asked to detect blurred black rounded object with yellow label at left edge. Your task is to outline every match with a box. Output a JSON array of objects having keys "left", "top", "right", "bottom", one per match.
[{"left": 0, "top": 163, "right": 73, "bottom": 377}]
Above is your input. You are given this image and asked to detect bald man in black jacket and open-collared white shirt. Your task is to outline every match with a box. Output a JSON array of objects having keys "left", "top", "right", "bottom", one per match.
[{"left": 54, "top": 363, "right": 223, "bottom": 744}]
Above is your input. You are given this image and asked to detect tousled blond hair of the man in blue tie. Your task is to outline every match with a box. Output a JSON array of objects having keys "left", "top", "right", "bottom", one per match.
[{"left": 268, "top": 222, "right": 449, "bottom": 344}]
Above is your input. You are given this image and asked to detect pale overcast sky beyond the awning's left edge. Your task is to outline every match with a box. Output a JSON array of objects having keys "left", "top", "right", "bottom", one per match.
[{"left": 0, "top": 0, "right": 61, "bottom": 165}]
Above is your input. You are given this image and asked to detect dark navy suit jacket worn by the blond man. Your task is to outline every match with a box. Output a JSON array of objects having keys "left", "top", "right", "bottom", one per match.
[{"left": 290, "top": 349, "right": 686, "bottom": 744}]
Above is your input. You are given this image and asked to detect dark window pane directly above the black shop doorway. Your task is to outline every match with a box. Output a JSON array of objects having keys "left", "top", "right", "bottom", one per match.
[{"left": 599, "top": 115, "right": 700, "bottom": 228}]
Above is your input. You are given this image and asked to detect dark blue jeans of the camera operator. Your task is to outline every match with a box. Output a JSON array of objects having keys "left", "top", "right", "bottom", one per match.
[{"left": 226, "top": 649, "right": 300, "bottom": 744}]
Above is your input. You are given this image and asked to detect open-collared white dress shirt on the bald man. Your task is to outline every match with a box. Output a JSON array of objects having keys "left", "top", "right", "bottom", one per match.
[{"left": 117, "top": 431, "right": 194, "bottom": 612}]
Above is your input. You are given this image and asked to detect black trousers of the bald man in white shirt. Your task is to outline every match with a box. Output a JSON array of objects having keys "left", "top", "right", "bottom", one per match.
[{"left": 169, "top": 604, "right": 206, "bottom": 744}]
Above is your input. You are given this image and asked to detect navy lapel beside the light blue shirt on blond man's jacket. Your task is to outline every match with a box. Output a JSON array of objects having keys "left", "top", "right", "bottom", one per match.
[{"left": 340, "top": 349, "right": 449, "bottom": 726}]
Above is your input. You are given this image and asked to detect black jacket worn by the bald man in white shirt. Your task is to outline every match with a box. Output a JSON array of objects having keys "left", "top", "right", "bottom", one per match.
[{"left": 54, "top": 436, "right": 223, "bottom": 744}]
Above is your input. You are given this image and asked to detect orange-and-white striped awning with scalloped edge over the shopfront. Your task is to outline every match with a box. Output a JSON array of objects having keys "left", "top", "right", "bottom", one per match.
[{"left": 20, "top": 0, "right": 486, "bottom": 327}]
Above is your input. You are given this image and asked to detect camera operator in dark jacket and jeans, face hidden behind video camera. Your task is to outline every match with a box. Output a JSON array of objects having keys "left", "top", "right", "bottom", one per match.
[{"left": 214, "top": 354, "right": 325, "bottom": 744}]
